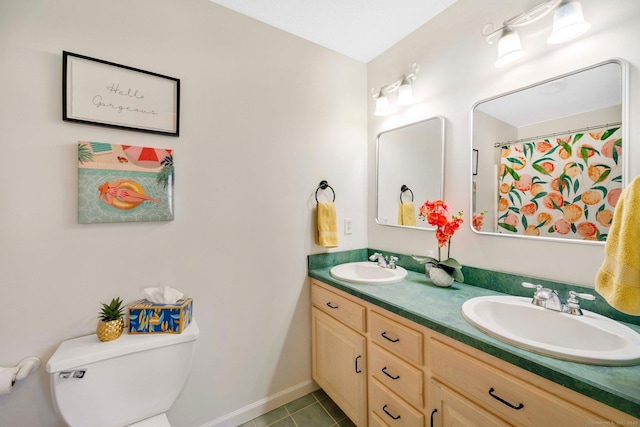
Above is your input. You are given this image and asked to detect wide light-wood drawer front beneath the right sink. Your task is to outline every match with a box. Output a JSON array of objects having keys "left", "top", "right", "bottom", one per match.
[{"left": 430, "top": 340, "right": 604, "bottom": 426}]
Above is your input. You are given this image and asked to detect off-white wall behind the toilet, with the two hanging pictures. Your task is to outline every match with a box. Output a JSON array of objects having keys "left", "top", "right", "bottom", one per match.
[{"left": 0, "top": 0, "right": 367, "bottom": 427}]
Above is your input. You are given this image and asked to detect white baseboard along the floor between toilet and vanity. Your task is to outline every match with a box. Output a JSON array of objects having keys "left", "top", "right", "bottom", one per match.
[{"left": 200, "top": 380, "right": 320, "bottom": 427}]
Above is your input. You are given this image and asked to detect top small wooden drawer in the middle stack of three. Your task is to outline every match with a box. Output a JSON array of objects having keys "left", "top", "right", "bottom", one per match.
[{"left": 369, "top": 311, "right": 422, "bottom": 366}]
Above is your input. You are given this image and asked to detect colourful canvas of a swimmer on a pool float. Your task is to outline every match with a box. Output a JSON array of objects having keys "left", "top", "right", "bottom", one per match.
[{"left": 78, "top": 141, "right": 174, "bottom": 224}]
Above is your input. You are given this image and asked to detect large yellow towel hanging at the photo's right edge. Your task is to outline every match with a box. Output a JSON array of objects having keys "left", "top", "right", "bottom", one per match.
[{"left": 596, "top": 177, "right": 640, "bottom": 316}]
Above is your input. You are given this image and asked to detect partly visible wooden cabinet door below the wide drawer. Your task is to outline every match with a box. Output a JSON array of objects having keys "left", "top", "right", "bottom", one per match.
[{"left": 430, "top": 381, "right": 509, "bottom": 427}]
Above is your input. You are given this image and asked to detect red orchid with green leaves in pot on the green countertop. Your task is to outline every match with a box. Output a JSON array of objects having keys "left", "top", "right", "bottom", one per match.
[{"left": 413, "top": 200, "right": 464, "bottom": 282}]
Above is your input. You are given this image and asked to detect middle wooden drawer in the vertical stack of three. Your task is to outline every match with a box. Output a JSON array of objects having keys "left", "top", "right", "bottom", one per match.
[{"left": 369, "top": 343, "right": 424, "bottom": 408}]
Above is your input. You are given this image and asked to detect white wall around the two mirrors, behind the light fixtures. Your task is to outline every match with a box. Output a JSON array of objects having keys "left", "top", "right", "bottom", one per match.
[{"left": 367, "top": 0, "right": 640, "bottom": 286}]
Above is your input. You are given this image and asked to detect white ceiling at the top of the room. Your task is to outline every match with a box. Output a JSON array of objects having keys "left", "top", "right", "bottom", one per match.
[{"left": 211, "top": 0, "right": 457, "bottom": 63}]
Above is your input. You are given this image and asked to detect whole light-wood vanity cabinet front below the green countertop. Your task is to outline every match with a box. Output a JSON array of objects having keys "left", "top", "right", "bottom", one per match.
[{"left": 311, "top": 279, "right": 640, "bottom": 427}]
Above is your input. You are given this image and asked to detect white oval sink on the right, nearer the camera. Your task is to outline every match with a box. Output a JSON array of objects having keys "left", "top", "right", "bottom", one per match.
[{"left": 462, "top": 296, "right": 640, "bottom": 366}]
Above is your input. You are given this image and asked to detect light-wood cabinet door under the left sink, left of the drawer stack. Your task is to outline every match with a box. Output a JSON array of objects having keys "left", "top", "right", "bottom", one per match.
[{"left": 311, "top": 307, "right": 367, "bottom": 427}]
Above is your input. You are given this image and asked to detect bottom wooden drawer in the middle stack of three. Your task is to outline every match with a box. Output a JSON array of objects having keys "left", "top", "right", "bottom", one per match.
[{"left": 369, "top": 379, "right": 424, "bottom": 427}]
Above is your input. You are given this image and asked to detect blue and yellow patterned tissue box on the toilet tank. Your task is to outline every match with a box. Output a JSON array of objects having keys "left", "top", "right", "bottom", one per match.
[{"left": 128, "top": 298, "right": 193, "bottom": 334}]
